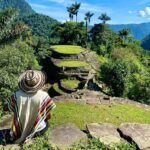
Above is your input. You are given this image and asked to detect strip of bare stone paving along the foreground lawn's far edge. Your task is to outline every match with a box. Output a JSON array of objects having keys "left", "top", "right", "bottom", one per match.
[{"left": 54, "top": 89, "right": 150, "bottom": 111}]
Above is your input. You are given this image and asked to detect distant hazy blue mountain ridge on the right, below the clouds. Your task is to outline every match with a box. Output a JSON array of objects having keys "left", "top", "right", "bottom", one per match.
[{"left": 111, "top": 23, "right": 150, "bottom": 40}]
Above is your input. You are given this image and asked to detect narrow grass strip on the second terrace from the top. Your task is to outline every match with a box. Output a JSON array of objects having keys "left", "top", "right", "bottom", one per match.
[{"left": 57, "top": 60, "right": 89, "bottom": 68}]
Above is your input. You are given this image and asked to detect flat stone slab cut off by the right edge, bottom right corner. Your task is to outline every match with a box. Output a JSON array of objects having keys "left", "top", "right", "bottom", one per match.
[{"left": 119, "top": 123, "right": 150, "bottom": 150}]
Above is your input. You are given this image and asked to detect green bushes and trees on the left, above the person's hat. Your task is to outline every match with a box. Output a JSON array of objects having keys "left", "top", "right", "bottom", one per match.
[{"left": 0, "top": 9, "right": 40, "bottom": 101}]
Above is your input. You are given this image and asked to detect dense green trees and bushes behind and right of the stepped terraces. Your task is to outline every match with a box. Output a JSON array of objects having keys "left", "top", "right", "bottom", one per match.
[{"left": 51, "top": 2, "right": 150, "bottom": 104}]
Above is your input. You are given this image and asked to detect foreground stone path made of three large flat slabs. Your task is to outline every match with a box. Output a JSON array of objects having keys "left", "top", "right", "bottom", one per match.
[{"left": 49, "top": 123, "right": 150, "bottom": 150}]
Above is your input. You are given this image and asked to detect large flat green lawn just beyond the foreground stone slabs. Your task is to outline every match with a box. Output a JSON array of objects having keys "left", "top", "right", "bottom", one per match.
[{"left": 51, "top": 103, "right": 150, "bottom": 129}]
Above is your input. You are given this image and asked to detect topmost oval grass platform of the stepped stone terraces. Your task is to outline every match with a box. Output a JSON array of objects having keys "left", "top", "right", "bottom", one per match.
[{"left": 51, "top": 45, "right": 84, "bottom": 54}]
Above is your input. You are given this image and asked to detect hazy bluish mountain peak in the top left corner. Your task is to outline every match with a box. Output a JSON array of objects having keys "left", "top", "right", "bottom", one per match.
[{"left": 0, "top": 0, "right": 35, "bottom": 17}]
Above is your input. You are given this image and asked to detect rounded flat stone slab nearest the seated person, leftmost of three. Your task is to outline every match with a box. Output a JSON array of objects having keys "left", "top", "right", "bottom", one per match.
[{"left": 49, "top": 124, "right": 87, "bottom": 148}]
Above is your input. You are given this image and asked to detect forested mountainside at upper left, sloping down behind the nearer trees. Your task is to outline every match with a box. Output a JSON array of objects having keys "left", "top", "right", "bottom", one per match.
[{"left": 0, "top": 0, "right": 58, "bottom": 40}]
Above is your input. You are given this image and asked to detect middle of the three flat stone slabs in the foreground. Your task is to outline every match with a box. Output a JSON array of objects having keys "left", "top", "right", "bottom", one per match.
[{"left": 86, "top": 123, "right": 121, "bottom": 145}]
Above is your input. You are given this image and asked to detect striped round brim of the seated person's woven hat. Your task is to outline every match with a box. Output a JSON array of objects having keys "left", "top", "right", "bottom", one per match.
[{"left": 18, "top": 71, "right": 46, "bottom": 94}]
